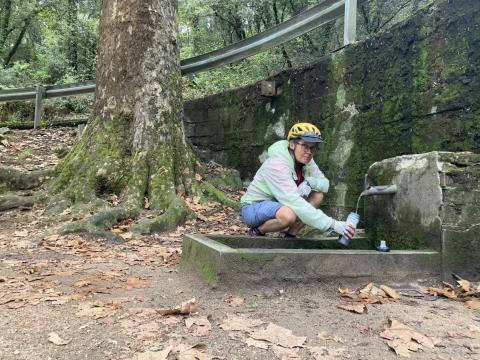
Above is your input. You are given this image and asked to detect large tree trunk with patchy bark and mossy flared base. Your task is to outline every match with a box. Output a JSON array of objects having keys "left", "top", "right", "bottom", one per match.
[{"left": 53, "top": 0, "right": 194, "bottom": 230}]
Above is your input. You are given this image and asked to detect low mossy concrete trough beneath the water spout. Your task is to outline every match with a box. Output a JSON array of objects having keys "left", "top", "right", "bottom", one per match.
[{"left": 182, "top": 235, "right": 441, "bottom": 285}]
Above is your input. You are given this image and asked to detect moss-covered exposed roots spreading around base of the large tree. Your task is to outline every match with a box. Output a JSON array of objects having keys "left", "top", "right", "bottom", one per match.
[{"left": 0, "top": 158, "right": 240, "bottom": 241}]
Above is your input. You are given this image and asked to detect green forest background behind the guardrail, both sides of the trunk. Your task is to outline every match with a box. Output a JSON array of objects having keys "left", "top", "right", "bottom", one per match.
[{"left": 0, "top": 0, "right": 433, "bottom": 123}]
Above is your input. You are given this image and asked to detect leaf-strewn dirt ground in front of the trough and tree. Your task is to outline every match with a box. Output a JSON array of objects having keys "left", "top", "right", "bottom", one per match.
[{"left": 0, "top": 129, "right": 480, "bottom": 360}]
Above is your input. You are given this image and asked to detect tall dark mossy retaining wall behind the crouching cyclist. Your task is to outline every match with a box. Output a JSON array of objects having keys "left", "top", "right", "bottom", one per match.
[{"left": 185, "top": 0, "right": 480, "bottom": 217}]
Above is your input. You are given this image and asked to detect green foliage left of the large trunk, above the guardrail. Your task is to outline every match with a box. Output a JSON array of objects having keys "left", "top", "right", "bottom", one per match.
[{"left": 0, "top": 0, "right": 99, "bottom": 88}]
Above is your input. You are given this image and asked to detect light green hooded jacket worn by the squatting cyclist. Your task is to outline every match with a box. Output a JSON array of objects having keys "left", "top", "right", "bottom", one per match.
[{"left": 240, "top": 140, "right": 333, "bottom": 231}]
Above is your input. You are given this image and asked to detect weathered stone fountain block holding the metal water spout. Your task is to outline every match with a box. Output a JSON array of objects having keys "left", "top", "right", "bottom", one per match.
[{"left": 363, "top": 152, "right": 480, "bottom": 280}]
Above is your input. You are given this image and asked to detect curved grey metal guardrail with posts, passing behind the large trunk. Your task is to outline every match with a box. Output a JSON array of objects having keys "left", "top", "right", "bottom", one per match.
[{"left": 0, "top": 0, "right": 365, "bottom": 129}]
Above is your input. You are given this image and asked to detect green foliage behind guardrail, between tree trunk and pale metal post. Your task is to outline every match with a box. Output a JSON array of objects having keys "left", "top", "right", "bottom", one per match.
[{"left": 180, "top": 0, "right": 323, "bottom": 100}]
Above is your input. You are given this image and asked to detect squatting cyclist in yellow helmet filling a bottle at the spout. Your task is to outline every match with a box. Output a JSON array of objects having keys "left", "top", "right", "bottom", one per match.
[{"left": 241, "top": 123, "right": 355, "bottom": 239}]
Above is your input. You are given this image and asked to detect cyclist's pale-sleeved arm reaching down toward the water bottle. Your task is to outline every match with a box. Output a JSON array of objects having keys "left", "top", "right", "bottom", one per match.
[{"left": 263, "top": 159, "right": 333, "bottom": 231}]
